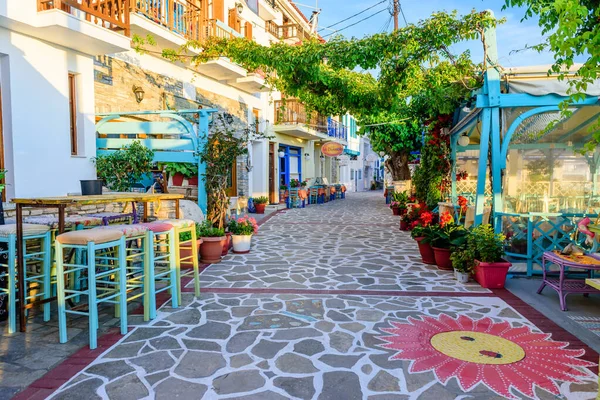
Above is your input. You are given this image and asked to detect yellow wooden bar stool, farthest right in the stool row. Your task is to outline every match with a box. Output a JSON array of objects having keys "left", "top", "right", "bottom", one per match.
[{"left": 164, "top": 219, "right": 200, "bottom": 304}]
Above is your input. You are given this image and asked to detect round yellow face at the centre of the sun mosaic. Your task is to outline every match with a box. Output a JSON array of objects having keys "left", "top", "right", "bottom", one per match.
[{"left": 431, "top": 331, "right": 525, "bottom": 365}]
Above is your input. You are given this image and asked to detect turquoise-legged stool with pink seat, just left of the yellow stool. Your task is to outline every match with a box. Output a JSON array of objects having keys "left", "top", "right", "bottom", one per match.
[{"left": 138, "top": 221, "right": 181, "bottom": 319}]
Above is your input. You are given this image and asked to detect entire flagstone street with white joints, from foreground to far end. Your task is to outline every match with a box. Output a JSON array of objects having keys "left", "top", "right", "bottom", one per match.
[{"left": 10, "top": 192, "right": 598, "bottom": 400}]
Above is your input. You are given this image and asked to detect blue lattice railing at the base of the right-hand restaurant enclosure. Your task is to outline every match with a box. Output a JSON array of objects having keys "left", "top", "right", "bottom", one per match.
[{"left": 495, "top": 212, "right": 598, "bottom": 276}]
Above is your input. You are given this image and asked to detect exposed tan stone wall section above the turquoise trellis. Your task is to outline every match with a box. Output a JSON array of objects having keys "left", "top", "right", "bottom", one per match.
[{"left": 94, "top": 56, "right": 250, "bottom": 196}]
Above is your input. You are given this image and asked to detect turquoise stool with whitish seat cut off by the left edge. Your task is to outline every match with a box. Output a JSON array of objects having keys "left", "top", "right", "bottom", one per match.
[{"left": 0, "top": 224, "right": 52, "bottom": 333}]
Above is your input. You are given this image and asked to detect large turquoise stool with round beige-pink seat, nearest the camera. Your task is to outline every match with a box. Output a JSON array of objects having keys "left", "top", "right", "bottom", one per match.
[{"left": 54, "top": 229, "right": 127, "bottom": 349}]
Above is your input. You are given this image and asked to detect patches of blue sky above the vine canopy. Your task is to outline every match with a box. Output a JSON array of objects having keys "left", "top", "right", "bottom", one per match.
[{"left": 295, "top": 0, "right": 553, "bottom": 68}]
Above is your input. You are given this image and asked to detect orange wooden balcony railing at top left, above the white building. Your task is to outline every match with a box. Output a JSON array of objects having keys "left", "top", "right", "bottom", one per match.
[{"left": 38, "top": 0, "right": 131, "bottom": 36}]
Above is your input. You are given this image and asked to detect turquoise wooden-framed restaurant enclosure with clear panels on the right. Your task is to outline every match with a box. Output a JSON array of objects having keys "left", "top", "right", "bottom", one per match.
[{"left": 450, "top": 20, "right": 600, "bottom": 275}]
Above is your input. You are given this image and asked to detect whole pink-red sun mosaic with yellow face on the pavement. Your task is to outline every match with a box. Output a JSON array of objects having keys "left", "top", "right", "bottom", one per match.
[{"left": 379, "top": 314, "right": 594, "bottom": 399}]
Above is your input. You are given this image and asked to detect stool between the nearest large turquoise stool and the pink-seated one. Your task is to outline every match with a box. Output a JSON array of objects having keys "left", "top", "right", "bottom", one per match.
[{"left": 96, "top": 224, "right": 154, "bottom": 321}]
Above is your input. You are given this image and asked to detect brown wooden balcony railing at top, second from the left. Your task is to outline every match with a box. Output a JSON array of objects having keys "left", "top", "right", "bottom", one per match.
[{"left": 130, "top": 0, "right": 203, "bottom": 40}]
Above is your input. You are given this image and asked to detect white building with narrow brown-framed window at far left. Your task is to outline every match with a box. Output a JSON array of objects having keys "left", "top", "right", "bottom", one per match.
[{"left": 0, "top": 0, "right": 130, "bottom": 199}]
